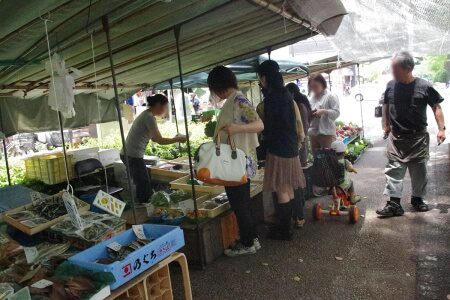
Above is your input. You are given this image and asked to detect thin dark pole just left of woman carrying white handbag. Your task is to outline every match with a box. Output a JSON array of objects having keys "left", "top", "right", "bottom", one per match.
[{"left": 173, "top": 26, "right": 205, "bottom": 268}]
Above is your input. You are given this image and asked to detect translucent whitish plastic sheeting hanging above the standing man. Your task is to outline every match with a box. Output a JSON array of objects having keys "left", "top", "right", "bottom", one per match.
[{"left": 308, "top": 0, "right": 450, "bottom": 61}]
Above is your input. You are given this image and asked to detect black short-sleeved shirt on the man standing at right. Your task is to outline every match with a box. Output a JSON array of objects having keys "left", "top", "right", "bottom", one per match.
[{"left": 384, "top": 78, "right": 444, "bottom": 133}]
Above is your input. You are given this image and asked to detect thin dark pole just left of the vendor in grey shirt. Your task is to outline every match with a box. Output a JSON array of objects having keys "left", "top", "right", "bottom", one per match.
[{"left": 102, "top": 16, "right": 137, "bottom": 224}]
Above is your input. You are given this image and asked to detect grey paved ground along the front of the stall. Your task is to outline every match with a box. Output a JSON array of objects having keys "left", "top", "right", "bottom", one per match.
[{"left": 173, "top": 137, "right": 450, "bottom": 300}]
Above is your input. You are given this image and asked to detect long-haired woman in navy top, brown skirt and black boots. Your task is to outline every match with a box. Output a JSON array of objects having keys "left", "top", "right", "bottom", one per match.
[{"left": 257, "top": 60, "right": 305, "bottom": 240}]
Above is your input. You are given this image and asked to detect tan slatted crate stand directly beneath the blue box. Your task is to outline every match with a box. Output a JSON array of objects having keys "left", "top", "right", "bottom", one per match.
[{"left": 106, "top": 252, "right": 192, "bottom": 300}]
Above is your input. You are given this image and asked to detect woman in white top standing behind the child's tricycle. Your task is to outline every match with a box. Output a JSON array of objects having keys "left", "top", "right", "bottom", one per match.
[{"left": 308, "top": 74, "right": 340, "bottom": 154}]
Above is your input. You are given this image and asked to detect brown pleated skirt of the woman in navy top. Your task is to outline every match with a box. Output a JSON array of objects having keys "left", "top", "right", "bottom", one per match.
[{"left": 264, "top": 153, "right": 306, "bottom": 192}]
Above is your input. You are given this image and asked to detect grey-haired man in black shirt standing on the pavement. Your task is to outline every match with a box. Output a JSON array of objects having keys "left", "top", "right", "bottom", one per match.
[{"left": 377, "top": 52, "right": 445, "bottom": 217}]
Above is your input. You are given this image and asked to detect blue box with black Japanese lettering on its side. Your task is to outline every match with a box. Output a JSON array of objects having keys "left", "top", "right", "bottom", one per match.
[{"left": 69, "top": 224, "right": 184, "bottom": 290}]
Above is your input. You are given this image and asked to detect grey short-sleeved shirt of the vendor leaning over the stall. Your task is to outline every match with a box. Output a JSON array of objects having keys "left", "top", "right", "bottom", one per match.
[{"left": 121, "top": 110, "right": 158, "bottom": 158}]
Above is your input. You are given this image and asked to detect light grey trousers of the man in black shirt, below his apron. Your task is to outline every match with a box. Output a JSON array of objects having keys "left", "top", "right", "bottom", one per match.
[{"left": 384, "top": 160, "right": 428, "bottom": 198}]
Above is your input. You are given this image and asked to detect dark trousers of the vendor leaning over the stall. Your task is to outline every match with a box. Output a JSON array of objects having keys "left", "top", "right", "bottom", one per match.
[{"left": 120, "top": 155, "right": 153, "bottom": 203}]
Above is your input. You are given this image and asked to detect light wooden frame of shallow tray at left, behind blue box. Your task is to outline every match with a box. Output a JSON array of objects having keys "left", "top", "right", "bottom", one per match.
[{"left": 3, "top": 192, "right": 90, "bottom": 235}]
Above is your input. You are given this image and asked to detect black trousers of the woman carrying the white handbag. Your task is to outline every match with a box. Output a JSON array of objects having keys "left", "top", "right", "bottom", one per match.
[{"left": 225, "top": 180, "right": 257, "bottom": 247}]
